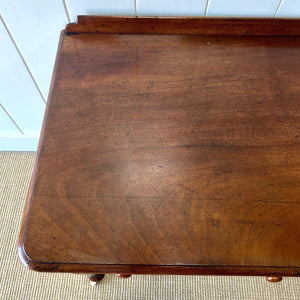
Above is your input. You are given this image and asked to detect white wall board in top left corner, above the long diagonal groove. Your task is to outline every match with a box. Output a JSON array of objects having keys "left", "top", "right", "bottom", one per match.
[{"left": 0, "top": 0, "right": 68, "bottom": 99}]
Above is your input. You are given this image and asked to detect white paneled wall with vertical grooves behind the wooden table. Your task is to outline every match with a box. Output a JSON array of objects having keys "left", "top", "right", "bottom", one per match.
[{"left": 0, "top": 0, "right": 300, "bottom": 151}]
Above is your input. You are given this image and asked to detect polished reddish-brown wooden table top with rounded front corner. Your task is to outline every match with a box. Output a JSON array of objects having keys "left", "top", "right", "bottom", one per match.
[{"left": 19, "top": 17, "right": 300, "bottom": 276}]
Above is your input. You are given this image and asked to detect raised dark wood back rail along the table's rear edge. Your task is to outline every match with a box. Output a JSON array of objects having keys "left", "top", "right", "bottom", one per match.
[{"left": 66, "top": 16, "right": 300, "bottom": 36}]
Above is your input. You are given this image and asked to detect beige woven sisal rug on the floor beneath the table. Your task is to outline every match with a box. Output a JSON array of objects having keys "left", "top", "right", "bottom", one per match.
[{"left": 0, "top": 152, "right": 300, "bottom": 300}]
